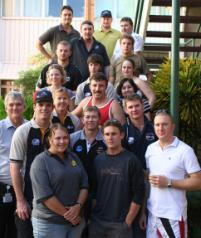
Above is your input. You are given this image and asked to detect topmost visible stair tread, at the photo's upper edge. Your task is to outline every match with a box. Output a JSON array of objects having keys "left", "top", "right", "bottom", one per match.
[{"left": 152, "top": 0, "right": 201, "bottom": 7}]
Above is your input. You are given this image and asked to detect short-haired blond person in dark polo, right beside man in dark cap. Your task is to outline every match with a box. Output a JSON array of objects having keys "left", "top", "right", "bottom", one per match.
[{"left": 52, "top": 87, "right": 80, "bottom": 134}]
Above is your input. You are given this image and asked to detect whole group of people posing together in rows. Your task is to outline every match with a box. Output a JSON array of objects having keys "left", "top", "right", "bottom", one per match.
[{"left": 0, "top": 3, "right": 201, "bottom": 238}]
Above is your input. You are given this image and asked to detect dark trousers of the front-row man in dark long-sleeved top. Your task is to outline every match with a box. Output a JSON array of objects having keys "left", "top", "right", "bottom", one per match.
[{"left": 89, "top": 219, "right": 133, "bottom": 238}]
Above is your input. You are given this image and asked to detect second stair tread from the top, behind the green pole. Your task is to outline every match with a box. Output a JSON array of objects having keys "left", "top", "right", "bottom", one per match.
[{"left": 149, "top": 15, "right": 201, "bottom": 24}]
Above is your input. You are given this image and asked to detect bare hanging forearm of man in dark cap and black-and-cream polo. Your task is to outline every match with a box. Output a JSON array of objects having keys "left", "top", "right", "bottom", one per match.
[{"left": 10, "top": 161, "right": 31, "bottom": 220}]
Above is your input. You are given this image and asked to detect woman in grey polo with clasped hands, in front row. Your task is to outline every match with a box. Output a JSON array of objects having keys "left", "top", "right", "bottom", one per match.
[{"left": 30, "top": 124, "right": 88, "bottom": 238}]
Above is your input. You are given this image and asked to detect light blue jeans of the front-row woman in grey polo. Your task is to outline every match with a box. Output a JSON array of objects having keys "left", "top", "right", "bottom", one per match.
[{"left": 32, "top": 217, "right": 85, "bottom": 238}]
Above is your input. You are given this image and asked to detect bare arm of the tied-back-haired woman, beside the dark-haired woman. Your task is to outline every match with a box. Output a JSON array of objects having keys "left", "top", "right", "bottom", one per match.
[{"left": 134, "top": 78, "right": 156, "bottom": 108}]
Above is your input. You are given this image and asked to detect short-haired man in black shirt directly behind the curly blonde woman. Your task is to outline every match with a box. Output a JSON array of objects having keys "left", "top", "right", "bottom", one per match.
[{"left": 36, "top": 41, "right": 82, "bottom": 91}]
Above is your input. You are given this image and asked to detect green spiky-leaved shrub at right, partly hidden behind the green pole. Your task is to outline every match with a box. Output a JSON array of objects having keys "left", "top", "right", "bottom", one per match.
[{"left": 152, "top": 59, "right": 201, "bottom": 152}]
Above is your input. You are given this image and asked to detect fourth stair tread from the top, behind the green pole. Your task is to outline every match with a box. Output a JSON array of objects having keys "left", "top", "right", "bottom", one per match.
[{"left": 144, "top": 45, "right": 201, "bottom": 52}]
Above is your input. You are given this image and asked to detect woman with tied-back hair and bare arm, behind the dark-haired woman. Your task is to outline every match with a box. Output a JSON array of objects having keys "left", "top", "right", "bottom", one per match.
[{"left": 121, "top": 59, "right": 156, "bottom": 109}]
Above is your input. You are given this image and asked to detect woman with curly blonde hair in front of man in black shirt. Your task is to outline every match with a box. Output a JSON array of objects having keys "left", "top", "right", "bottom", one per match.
[{"left": 44, "top": 64, "right": 75, "bottom": 111}]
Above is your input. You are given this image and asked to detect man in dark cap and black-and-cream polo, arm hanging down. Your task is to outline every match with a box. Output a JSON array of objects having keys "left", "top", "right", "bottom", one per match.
[{"left": 10, "top": 90, "right": 53, "bottom": 238}]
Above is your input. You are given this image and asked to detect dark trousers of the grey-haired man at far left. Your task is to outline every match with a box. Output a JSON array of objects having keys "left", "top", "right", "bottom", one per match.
[{"left": 0, "top": 182, "right": 17, "bottom": 238}]
